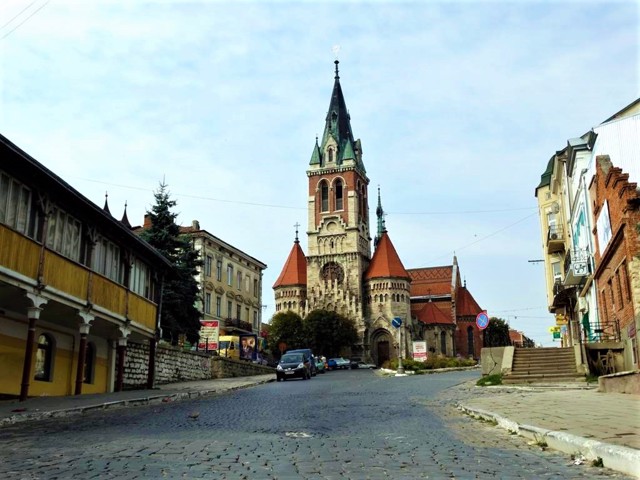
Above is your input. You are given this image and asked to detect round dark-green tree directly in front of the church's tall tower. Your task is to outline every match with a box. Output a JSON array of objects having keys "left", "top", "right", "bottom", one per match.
[{"left": 304, "top": 310, "right": 358, "bottom": 357}]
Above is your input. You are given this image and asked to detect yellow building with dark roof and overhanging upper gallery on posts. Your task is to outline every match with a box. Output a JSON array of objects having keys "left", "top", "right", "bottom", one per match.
[{"left": 0, "top": 135, "right": 170, "bottom": 400}]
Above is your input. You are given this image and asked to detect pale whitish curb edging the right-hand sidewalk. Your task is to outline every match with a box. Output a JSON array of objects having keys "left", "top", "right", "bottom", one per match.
[{"left": 458, "top": 405, "right": 640, "bottom": 478}]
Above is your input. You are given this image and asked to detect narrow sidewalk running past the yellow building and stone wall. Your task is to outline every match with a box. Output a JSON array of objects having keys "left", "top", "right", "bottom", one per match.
[{"left": 0, "top": 374, "right": 276, "bottom": 428}]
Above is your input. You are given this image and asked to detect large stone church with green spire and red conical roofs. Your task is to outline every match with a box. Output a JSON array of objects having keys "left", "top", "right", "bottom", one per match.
[{"left": 273, "top": 60, "right": 483, "bottom": 365}]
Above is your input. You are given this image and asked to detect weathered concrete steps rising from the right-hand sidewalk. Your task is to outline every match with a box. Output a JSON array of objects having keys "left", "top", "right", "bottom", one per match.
[{"left": 502, "top": 348, "right": 585, "bottom": 384}]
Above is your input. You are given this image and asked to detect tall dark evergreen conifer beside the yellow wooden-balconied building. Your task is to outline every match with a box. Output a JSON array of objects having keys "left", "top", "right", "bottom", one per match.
[{"left": 140, "top": 182, "right": 202, "bottom": 345}]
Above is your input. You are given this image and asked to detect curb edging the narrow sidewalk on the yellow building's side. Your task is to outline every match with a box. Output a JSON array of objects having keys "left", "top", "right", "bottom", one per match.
[{"left": 0, "top": 378, "right": 274, "bottom": 428}]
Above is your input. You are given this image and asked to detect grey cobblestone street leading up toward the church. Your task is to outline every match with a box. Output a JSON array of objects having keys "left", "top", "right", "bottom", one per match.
[{"left": 0, "top": 370, "right": 626, "bottom": 479}]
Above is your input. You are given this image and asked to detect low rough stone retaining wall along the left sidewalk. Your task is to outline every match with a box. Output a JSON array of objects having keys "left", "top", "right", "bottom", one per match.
[{"left": 124, "top": 342, "right": 275, "bottom": 390}]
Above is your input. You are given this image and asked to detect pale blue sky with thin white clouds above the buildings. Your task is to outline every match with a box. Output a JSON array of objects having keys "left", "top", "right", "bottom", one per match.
[{"left": 0, "top": 0, "right": 640, "bottom": 346}]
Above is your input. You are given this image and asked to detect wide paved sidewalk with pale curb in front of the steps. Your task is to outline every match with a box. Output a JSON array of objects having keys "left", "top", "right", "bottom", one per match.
[{"left": 459, "top": 385, "right": 640, "bottom": 478}]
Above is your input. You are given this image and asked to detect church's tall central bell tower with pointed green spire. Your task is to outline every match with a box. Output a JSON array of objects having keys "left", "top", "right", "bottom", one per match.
[{"left": 307, "top": 60, "right": 371, "bottom": 324}]
